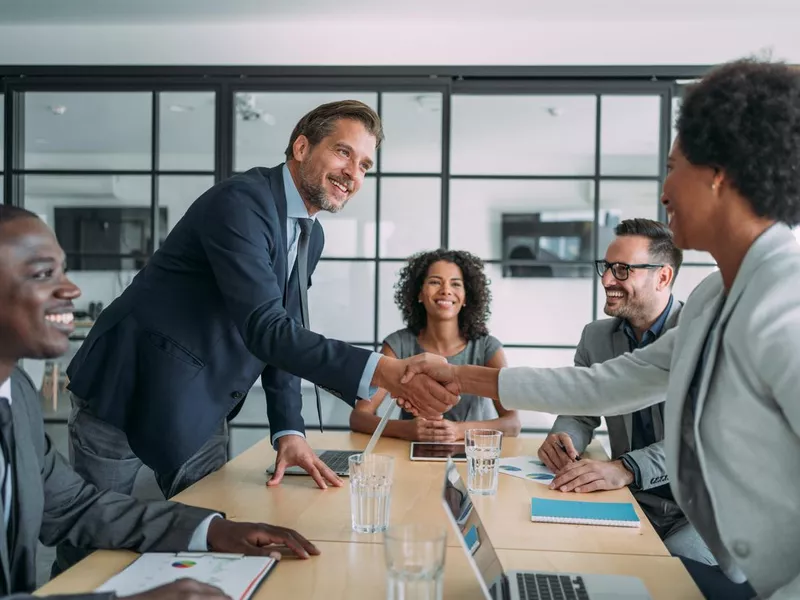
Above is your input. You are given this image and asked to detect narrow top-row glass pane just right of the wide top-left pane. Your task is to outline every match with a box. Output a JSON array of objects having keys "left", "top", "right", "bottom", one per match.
[{"left": 158, "top": 92, "right": 215, "bottom": 171}]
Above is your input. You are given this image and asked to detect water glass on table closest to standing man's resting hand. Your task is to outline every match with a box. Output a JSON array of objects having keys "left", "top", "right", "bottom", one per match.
[{"left": 348, "top": 454, "right": 394, "bottom": 533}]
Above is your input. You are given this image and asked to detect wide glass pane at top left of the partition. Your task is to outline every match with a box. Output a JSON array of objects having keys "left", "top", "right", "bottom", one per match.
[{"left": 24, "top": 92, "right": 153, "bottom": 170}]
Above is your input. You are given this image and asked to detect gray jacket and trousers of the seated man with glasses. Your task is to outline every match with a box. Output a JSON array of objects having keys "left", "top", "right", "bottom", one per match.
[{"left": 550, "top": 300, "right": 716, "bottom": 565}]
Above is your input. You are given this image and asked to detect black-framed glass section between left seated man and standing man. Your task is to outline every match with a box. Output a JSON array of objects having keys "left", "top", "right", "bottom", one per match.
[{"left": 16, "top": 88, "right": 217, "bottom": 416}]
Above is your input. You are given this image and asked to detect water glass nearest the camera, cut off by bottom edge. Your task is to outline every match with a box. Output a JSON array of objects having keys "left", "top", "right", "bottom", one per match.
[{"left": 384, "top": 524, "right": 446, "bottom": 600}]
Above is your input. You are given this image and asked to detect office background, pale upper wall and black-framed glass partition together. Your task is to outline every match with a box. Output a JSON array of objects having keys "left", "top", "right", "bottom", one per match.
[{"left": 0, "top": 0, "right": 800, "bottom": 454}]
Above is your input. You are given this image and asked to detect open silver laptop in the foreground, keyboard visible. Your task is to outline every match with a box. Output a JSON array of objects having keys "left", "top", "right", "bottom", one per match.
[{"left": 442, "top": 461, "right": 652, "bottom": 600}]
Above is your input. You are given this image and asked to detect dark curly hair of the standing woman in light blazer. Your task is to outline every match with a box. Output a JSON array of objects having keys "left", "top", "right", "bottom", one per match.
[{"left": 677, "top": 59, "right": 800, "bottom": 225}]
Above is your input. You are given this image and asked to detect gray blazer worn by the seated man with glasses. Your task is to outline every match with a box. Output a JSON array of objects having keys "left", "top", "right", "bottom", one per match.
[{"left": 551, "top": 300, "right": 683, "bottom": 524}]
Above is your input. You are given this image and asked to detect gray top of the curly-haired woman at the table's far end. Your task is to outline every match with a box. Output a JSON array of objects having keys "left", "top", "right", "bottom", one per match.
[{"left": 384, "top": 329, "right": 503, "bottom": 421}]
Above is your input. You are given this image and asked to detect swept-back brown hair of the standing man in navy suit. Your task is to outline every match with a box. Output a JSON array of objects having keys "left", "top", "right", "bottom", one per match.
[{"left": 286, "top": 100, "right": 383, "bottom": 160}]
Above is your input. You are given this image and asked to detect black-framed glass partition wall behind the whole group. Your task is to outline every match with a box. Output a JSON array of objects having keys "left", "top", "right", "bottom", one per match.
[{"left": 0, "top": 74, "right": 700, "bottom": 452}]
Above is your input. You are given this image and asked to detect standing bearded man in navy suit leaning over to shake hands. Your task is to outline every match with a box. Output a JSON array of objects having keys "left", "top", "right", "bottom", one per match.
[{"left": 58, "top": 100, "right": 458, "bottom": 567}]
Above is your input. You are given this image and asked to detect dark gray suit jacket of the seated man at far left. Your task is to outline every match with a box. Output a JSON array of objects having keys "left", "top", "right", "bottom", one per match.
[{"left": 0, "top": 369, "right": 212, "bottom": 598}]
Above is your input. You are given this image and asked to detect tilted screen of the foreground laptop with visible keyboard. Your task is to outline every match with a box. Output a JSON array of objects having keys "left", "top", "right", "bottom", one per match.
[{"left": 442, "top": 462, "right": 503, "bottom": 592}]
